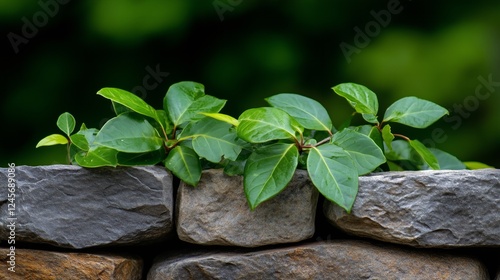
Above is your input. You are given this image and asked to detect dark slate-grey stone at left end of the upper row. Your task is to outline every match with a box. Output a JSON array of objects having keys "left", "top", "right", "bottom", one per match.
[{"left": 0, "top": 165, "right": 173, "bottom": 248}]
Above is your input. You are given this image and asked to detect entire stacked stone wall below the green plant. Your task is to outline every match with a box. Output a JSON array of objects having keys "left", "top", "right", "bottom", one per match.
[{"left": 0, "top": 165, "right": 500, "bottom": 280}]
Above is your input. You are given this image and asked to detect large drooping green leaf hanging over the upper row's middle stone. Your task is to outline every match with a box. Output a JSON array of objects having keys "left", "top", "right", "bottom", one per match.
[{"left": 243, "top": 143, "right": 299, "bottom": 210}]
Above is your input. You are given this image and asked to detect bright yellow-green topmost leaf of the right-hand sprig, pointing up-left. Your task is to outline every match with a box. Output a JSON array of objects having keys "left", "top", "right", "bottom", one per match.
[{"left": 332, "top": 83, "right": 378, "bottom": 123}]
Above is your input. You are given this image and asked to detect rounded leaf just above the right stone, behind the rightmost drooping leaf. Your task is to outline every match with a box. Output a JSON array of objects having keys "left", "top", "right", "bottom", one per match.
[{"left": 332, "top": 129, "right": 385, "bottom": 175}]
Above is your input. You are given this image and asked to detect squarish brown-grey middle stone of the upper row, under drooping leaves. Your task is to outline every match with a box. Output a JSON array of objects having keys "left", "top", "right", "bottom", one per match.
[{"left": 176, "top": 167, "right": 318, "bottom": 247}]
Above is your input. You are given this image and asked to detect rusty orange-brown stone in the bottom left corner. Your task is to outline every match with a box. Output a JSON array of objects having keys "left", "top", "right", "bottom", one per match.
[{"left": 0, "top": 248, "right": 142, "bottom": 280}]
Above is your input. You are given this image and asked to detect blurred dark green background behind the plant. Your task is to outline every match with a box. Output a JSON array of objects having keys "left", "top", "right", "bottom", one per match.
[{"left": 0, "top": 0, "right": 500, "bottom": 168}]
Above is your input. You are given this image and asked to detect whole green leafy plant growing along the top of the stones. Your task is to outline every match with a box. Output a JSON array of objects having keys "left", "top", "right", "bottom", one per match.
[{"left": 37, "top": 82, "right": 480, "bottom": 211}]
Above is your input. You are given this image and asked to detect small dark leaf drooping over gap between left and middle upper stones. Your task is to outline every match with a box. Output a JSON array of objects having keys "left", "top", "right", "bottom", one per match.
[{"left": 165, "top": 146, "right": 201, "bottom": 186}]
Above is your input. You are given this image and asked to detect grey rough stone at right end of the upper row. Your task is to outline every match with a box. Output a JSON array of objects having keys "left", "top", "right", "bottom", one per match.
[{"left": 324, "top": 169, "right": 500, "bottom": 248}]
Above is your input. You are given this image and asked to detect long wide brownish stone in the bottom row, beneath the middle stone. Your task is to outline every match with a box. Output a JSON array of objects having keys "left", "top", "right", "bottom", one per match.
[{"left": 148, "top": 240, "right": 489, "bottom": 280}]
